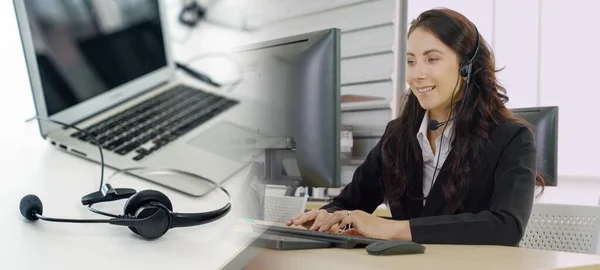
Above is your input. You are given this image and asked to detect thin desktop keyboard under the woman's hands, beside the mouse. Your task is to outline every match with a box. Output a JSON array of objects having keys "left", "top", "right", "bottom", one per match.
[{"left": 252, "top": 224, "right": 382, "bottom": 248}]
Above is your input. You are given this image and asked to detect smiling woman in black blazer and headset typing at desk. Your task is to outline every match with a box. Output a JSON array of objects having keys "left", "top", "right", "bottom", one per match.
[{"left": 287, "top": 9, "right": 543, "bottom": 246}]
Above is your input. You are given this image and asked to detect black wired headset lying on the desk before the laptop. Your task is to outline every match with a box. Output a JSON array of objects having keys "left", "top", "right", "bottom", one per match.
[{"left": 19, "top": 117, "right": 231, "bottom": 239}]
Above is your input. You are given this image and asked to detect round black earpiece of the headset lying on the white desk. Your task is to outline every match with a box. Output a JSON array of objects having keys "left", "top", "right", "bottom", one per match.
[{"left": 124, "top": 190, "right": 173, "bottom": 239}]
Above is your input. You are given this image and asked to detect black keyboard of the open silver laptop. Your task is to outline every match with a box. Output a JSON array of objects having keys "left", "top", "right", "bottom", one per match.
[{"left": 71, "top": 85, "right": 238, "bottom": 160}]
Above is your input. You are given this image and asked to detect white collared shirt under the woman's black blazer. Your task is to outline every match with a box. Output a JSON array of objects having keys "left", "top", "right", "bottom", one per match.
[{"left": 417, "top": 111, "right": 454, "bottom": 204}]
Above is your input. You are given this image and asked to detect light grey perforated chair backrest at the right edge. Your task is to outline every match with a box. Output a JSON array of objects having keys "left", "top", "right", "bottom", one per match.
[{"left": 519, "top": 203, "right": 600, "bottom": 254}]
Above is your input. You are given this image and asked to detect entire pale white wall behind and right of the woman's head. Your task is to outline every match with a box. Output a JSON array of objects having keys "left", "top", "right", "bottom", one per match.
[{"left": 408, "top": 0, "right": 600, "bottom": 179}]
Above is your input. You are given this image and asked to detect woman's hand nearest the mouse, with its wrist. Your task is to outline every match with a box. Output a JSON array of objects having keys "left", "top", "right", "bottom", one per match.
[{"left": 318, "top": 210, "right": 411, "bottom": 241}]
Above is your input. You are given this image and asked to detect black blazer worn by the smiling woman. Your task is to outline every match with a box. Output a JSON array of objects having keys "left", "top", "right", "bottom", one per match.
[{"left": 321, "top": 121, "right": 537, "bottom": 246}]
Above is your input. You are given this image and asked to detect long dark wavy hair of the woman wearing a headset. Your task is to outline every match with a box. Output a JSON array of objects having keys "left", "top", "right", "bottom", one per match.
[{"left": 382, "top": 8, "right": 544, "bottom": 213}]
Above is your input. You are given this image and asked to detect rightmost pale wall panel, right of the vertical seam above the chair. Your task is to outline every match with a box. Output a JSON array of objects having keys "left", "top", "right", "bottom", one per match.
[{"left": 538, "top": 0, "right": 600, "bottom": 175}]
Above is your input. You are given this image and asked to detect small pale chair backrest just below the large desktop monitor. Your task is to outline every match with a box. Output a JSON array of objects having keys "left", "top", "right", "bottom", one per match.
[{"left": 264, "top": 195, "right": 308, "bottom": 223}]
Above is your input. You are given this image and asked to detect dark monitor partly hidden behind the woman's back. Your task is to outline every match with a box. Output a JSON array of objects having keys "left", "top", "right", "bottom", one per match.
[{"left": 512, "top": 106, "right": 558, "bottom": 186}]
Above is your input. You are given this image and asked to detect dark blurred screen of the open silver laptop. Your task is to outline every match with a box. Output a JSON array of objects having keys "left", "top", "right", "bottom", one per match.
[{"left": 25, "top": 0, "right": 167, "bottom": 115}]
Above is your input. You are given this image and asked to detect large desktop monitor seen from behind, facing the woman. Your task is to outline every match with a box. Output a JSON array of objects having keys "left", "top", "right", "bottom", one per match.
[{"left": 230, "top": 29, "right": 341, "bottom": 187}]
